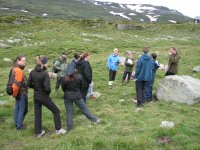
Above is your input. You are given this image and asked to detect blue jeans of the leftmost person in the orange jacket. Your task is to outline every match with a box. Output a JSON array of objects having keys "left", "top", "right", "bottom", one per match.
[{"left": 14, "top": 94, "right": 28, "bottom": 129}]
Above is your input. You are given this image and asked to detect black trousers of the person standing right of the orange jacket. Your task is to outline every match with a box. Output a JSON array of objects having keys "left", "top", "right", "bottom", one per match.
[{"left": 34, "top": 94, "right": 61, "bottom": 134}]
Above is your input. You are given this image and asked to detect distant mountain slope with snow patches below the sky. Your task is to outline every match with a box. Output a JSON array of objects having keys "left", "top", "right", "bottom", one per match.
[{"left": 0, "top": 0, "right": 191, "bottom": 23}]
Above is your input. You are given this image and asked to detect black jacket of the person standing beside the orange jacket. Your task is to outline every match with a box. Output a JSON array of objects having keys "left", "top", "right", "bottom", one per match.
[{"left": 28, "top": 65, "right": 51, "bottom": 96}]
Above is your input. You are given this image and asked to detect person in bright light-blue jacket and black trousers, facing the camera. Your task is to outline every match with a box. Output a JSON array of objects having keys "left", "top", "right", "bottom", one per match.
[{"left": 108, "top": 48, "right": 120, "bottom": 88}]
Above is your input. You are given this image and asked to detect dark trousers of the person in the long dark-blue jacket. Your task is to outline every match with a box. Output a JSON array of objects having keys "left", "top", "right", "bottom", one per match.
[{"left": 135, "top": 80, "right": 146, "bottom": 107}]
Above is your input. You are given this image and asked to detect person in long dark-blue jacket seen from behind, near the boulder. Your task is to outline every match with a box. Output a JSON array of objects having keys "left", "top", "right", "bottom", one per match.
[{"left": 134, "top": 47, "right": 153, "bottom": 107}]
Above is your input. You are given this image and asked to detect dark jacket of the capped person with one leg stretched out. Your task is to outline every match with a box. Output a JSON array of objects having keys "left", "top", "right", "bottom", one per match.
[{"left": 62, "top": 74, "right": 83, "bottom": 100}]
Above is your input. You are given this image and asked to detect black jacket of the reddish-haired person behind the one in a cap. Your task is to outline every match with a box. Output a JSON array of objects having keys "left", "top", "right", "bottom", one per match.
[{"left": 77, "top": 60, "right": 92, "bottom": 87}]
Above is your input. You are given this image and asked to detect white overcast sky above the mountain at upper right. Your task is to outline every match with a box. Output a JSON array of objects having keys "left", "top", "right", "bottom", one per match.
[{"left": 96, "top": 0, "right": 200, "bottom": 18}]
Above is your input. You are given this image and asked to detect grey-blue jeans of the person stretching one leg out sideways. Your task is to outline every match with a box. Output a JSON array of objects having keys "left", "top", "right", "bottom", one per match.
[{"left": 64, "top": 99, "right": 97, "bottom": 131}]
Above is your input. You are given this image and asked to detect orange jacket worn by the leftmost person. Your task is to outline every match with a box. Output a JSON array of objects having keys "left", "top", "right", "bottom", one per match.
[{"left": 12, "top": 67, "right": 24, "bottom": 97}]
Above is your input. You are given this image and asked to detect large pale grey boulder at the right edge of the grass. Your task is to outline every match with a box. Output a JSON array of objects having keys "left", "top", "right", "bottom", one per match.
[{"left": 156, "top": 75, "right": 200, "bottom": 105}]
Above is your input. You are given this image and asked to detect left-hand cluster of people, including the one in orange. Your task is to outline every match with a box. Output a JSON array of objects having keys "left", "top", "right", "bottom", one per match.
[{"left": 8, "top": 53, "right": 101, "bottom": 137}]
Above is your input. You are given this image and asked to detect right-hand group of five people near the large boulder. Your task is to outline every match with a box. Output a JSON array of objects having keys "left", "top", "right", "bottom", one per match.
[{"left": 107, "top": 47, "right": 180, "bottom": 107}]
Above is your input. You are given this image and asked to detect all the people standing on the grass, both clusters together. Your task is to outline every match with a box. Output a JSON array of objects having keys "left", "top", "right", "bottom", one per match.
[{"left": 7, "top": 47, "right": 180, "bottom": 137}]
